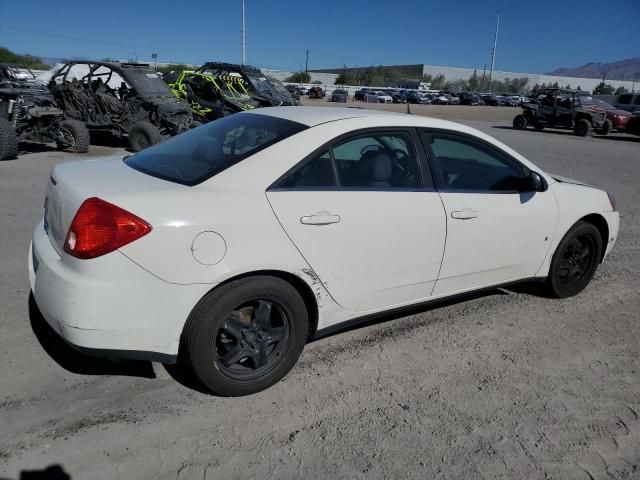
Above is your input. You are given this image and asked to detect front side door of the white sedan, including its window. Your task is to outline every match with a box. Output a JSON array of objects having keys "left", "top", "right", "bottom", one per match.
[{"left": 422, "top": 131, "right": 558, "bottom": 295}]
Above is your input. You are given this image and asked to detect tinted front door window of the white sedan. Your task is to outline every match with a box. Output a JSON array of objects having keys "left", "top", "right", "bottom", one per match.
[{"left": 427, "top": 133, "right": 525, "bottom": 192}]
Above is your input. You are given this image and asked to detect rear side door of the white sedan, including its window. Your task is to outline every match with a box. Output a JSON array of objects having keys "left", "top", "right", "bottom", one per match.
[{"left": 267, "top": 129, "right": 446, "bottom": 311}]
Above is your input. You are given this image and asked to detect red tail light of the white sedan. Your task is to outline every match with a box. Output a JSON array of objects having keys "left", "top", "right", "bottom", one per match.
[{"left": 64, "top": 197, "right": 151, "bottom": 259}]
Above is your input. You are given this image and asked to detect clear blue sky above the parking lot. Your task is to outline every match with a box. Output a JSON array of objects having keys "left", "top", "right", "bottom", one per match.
[{"left": 0, "top": 0, "right": 640, "bottom": 73}]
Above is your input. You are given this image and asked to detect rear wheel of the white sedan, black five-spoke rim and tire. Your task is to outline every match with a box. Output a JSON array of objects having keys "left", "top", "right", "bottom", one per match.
[{"left": 183, "top": 276, "right": 309, "bottom": 396}]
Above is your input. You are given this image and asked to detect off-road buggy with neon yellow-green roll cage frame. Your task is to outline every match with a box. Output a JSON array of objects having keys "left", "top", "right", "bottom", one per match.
[{"left": 165, "top": 70, "right": 260, "bottom": 123}]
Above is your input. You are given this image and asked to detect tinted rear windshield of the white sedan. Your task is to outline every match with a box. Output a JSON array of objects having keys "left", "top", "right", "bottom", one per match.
[{"left": 125, "top": 113, "right": 308, "bottom": 186}]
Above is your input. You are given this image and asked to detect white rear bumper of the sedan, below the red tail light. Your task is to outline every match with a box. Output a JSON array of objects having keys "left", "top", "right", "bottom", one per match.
[{"left": 29, "top": 223, "right": 211, "bottom": 363}]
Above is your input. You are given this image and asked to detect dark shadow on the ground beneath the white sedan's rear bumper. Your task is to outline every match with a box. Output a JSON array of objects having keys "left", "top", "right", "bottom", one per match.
[{"left": 28, "top": 293, "right": 156, "bottom": 378}]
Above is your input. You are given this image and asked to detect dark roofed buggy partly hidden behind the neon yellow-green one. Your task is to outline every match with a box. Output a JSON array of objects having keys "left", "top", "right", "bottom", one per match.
[{"left": 196, "top": 62, "right": 300, "bottom": 107}]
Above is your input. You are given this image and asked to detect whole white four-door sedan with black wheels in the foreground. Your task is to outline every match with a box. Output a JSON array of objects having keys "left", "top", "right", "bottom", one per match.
[{"left": 29, "top": 107, "right": 619, "bottom": 395}]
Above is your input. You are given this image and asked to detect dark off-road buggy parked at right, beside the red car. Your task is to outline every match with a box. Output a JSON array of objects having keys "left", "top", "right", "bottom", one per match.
[{"left": 513, "top": 88, "right": 612, "bottom": 137}]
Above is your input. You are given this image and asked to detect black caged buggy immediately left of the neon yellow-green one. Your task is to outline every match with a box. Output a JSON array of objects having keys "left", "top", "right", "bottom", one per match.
[{"left": 49, "top": 61, "right": 193, "bottom": 152}]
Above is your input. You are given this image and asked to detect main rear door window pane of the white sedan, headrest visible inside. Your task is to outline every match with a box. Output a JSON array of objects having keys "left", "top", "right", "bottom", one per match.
[{"left": 333, "top": 132, "right": 421, "bottom": 189}]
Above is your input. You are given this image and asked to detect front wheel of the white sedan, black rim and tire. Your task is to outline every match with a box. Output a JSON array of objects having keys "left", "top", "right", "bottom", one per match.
[{"left": 545, "top": 221, "right": 603, "bottom": 298}]
